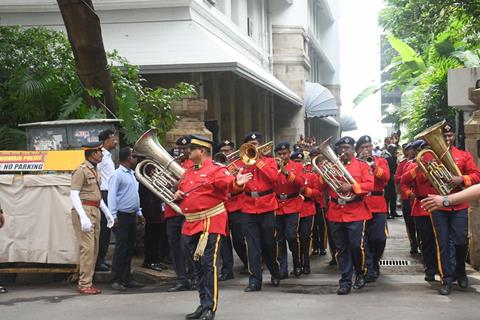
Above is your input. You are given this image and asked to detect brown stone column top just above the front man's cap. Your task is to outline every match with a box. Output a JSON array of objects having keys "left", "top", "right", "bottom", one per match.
[{"left": 166, "top": 98, "right": 212, "bottom": 148}]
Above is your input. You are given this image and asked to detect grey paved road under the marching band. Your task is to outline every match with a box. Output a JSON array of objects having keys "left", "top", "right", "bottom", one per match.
[{"left": 0, "top": 219, "right": 480, "bottom": 320}]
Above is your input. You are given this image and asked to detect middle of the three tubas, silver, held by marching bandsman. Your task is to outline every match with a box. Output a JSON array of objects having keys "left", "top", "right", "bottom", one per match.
[{"left": 312, "top": 137, "right": 357, "bottom": 201}]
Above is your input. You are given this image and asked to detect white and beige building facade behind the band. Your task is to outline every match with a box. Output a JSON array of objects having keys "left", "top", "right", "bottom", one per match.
[{"left": 0, "top": 0, "right": 340, "bottom": 145}]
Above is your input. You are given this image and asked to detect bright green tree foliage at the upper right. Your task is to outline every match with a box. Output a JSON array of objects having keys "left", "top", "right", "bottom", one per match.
[{"left": 354, "top": 0, "right": 480, "bottom": 139}]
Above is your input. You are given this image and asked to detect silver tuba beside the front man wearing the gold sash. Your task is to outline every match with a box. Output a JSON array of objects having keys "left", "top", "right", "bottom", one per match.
[{"left": 133, "top": 129, "right": 185, "bottom": 214}]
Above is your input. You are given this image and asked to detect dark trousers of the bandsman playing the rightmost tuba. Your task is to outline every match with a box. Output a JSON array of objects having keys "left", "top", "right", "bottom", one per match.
[{"left": 431, "top": 209, "right": 468, "bottom": 283}]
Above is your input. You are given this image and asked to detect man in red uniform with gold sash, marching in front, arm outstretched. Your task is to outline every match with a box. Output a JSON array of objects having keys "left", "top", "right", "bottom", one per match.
[{"left": 175, "top": 135, "right": 252, "bottom": 320}]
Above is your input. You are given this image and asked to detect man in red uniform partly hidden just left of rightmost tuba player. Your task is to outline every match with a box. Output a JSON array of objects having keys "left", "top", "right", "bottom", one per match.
[{"left": 400, "top": 140, "right": 437, "bottom": 282}]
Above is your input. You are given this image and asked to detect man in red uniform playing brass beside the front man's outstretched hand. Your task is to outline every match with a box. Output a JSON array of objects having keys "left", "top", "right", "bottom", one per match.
[{"left": 242, "top": 132, "right": 280, "bottom": 292}]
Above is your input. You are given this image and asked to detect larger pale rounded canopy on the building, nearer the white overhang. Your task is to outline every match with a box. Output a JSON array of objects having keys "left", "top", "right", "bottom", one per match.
[{"left": 304, "top": 82, "right": 338, "bottom": 118}]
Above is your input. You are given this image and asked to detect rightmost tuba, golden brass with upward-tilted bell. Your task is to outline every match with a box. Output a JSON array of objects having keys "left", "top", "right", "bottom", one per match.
[{"left": 415, "top": 120, "right": 462, "bottom": 196}]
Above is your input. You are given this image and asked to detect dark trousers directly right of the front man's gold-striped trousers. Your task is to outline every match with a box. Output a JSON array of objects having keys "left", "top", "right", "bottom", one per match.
[{"left": 221, "top": 211, "right": 248, "bottom": 274}]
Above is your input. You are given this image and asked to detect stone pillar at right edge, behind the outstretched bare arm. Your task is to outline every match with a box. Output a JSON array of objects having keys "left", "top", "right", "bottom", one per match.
[{"left": 465, "top": 88, "right": 480, "bottom": 269}]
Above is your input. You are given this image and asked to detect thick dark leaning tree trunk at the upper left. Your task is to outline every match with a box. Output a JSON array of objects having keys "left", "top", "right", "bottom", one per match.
[{"left": 57, "top": 0, "right": 117, "bottom": 117}]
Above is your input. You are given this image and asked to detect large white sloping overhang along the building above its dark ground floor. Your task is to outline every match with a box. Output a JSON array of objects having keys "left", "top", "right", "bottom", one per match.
[{"left": 102, "top": 20, "right": 303, "bottom": 106}]
